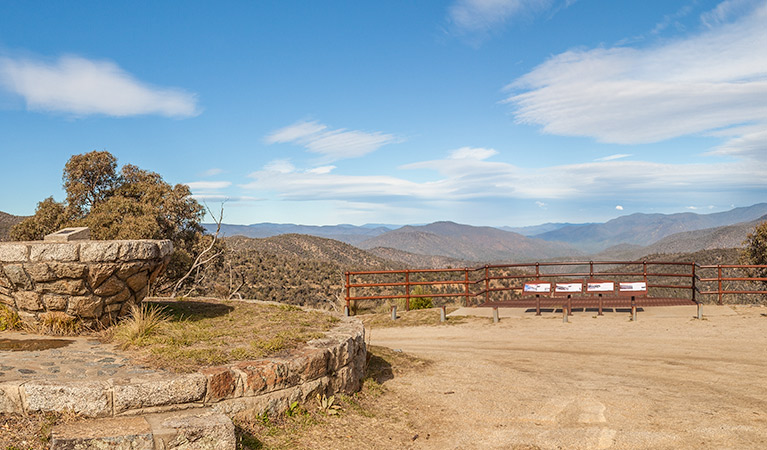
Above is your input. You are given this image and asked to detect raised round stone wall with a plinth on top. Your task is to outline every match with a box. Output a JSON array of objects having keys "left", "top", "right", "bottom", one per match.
[{"left": 0, "top": 240, "right": 173, "bottom": 325}]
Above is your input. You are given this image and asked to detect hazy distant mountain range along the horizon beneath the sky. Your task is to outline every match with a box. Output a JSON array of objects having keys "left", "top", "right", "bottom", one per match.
[{"left": 205, "top": 203, "right": 767, "bottom": 267}]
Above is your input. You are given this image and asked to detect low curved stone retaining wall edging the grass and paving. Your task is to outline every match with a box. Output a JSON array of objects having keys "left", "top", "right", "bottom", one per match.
[{"left": 0, "top": 318, "right": 367, "bottom": 417}]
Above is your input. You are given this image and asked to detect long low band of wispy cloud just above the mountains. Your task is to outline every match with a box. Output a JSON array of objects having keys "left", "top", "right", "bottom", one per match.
[{"left": 241, "top": 149, "right": 767, "bottom": 202}]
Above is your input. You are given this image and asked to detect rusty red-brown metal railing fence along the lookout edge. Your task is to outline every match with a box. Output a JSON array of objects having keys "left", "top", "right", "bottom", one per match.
[{"left": 345, "top": 261, "right": 767, "bottom": 311}]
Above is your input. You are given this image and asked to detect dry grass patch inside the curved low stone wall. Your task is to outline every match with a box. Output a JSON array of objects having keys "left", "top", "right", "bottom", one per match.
[{"left": 111, "top": 299, "right": 339, "bottom": 372}]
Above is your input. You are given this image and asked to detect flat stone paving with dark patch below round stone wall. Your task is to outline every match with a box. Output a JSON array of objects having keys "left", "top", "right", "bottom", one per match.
[{"left": 0, "top": 332, "right": 165, "bottom": 383}]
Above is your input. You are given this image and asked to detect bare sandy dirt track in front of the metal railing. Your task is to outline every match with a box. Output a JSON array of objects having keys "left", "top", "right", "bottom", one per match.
[{"left": 369, "top": 306, "right": 767, "bottom": 449}]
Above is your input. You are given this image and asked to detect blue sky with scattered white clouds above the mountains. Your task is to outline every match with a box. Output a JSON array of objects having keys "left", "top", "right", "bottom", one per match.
[{"left": 0, "top": 0, "right": 767, "bottom": 226}]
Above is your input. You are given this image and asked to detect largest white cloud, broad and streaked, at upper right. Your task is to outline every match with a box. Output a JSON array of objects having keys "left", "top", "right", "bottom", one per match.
[{"left": 507, "top": 2, "right": 767, "bottom": 152}]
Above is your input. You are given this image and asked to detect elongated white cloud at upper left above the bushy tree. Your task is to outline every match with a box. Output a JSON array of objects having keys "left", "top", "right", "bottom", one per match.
[{"left": 0, "top": 56, "right": 199, "bottom": 117}]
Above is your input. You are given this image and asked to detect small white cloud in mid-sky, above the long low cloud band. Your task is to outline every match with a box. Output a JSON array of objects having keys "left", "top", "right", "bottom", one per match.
[{"left": 266, "top": 122, "right": 397, "bottom": 160}]
